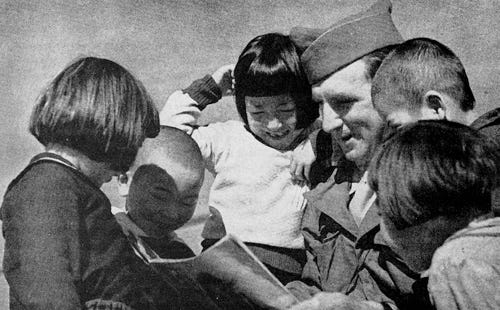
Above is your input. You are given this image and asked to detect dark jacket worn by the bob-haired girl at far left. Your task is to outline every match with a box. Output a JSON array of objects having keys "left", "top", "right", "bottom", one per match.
[{"left": 1, "top": 153, "right": 205, "bottom": 310}]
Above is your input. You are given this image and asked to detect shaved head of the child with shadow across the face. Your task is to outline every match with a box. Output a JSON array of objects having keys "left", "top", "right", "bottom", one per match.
[{"left": 127, "top": 126, "right": 204, "bottom": 238}]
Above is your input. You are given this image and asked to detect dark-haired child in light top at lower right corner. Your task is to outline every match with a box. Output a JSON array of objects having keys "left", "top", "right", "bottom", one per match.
[{"left": 369, "top": 121, "right": 500, "bottom": 309}]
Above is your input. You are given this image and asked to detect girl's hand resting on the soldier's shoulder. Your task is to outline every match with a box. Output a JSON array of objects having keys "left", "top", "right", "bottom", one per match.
[{"left": 290, "top": 139, "right": 316, "bottom": 182}]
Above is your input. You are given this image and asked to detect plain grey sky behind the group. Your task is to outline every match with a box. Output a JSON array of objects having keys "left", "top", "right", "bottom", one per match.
[{"left": 0, "top": 0, "right": 500, "bottom": 308}]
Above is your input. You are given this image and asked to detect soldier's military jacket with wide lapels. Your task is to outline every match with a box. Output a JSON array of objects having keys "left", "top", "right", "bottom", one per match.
[{"left": 302, "top": 160, "right": 426, "bottom": 308}]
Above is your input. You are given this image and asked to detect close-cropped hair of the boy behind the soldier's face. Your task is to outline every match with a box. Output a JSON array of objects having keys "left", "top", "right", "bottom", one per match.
[{"left": 372, "top": 38, "right": 475, "bottom": 112}]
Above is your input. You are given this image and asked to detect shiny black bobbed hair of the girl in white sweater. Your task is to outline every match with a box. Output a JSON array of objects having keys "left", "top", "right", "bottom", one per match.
[{"left": 234, "top": 33, "right": 319, "bottom": 128}]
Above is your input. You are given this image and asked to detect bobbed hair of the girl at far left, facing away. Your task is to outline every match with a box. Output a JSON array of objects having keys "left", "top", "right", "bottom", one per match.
[{"left": 29, "top": 57, "right": 160, "bottom": 171}]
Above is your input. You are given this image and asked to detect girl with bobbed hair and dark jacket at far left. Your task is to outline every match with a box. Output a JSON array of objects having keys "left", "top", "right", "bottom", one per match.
[{"left": 1, "top": 57, "right": 213, "bottom": 310}]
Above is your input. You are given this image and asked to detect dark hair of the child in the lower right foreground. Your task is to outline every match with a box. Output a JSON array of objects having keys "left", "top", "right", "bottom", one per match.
[{"left": 368, "top": 120, "right": 500, "bottom": 229}]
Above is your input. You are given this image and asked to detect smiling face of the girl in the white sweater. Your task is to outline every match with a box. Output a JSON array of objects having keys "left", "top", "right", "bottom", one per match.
[{"left": 245, "top": 94, "right": 300, "bottom": 150}]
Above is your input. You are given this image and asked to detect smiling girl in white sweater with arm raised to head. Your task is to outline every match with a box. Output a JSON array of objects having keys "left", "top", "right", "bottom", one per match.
[{"left": 160, "top": 33, "right": 318, "bottom": 282}]
